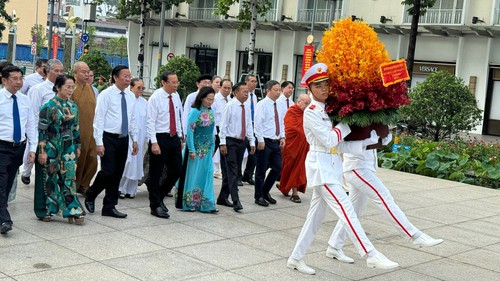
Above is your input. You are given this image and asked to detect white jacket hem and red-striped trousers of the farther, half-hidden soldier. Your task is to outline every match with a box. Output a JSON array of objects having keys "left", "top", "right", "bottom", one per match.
[{"left": 328, "top": 149, "right": 419, "bottom": 249}]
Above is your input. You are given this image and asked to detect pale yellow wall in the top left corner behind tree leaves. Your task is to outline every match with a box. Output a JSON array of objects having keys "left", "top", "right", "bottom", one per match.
[{"left": 1, "top": 0, "right": 48, "bottom": 45}]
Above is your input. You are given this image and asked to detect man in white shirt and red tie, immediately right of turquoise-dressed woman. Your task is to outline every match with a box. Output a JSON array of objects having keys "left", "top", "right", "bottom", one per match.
[{"left": 217, "top": 82, "right": 255, "bottom": 212}]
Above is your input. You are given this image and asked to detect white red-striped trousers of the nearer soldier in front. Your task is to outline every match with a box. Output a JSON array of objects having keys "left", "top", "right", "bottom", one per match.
[{"left": 291, "top": 184, "right": 374, "bottom": 260}]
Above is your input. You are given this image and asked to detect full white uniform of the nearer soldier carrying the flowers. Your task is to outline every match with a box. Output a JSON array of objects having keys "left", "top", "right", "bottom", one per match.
[{"left": 291, "top": 100, "right": 374, "bottom": 260}]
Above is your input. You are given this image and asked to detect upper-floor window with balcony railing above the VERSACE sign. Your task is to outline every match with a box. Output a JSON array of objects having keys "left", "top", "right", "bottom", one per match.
[{"left": 404, "top": 0, "right": 464, "bottom": 24}]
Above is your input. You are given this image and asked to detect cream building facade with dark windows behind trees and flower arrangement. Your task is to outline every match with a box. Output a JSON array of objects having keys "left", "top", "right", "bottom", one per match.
[{"left": 128, "top": 0, "right": 500, "bottom": 135}]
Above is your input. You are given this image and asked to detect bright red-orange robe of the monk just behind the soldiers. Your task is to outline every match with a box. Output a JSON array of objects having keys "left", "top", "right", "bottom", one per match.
[{"left": 280, "top": 104, "right": 309, "bottom": 194}]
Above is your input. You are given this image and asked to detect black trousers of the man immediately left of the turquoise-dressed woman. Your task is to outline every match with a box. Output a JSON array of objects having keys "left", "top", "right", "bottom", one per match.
[{"left": 148, "top": 133, "right": 182, "bottom": 210}]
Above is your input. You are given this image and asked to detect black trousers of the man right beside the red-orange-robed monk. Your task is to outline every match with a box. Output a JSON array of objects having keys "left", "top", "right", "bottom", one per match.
[{"left": 255, "top": 138, "right": 281, "bottom": 199}]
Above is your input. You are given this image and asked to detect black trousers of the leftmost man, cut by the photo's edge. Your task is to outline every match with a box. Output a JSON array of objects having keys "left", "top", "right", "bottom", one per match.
[{"left": 0, "top": 141, "right": 26, "bottom": 224}]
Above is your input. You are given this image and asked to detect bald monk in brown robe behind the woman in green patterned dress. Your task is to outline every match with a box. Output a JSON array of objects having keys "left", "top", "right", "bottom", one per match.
[{"left": 71, "top": 61, "right": 97, "bottom": 194}]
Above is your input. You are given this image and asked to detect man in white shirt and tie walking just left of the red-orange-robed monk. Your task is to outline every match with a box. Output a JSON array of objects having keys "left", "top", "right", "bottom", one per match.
[{"left": 254, "top": 80, "right": 285, "bottom": 207}]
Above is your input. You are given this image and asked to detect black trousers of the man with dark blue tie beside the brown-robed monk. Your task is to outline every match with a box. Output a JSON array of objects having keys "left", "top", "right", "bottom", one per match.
[{"left": 86, "top": 132, "right": 129, "bottom": 210}]
